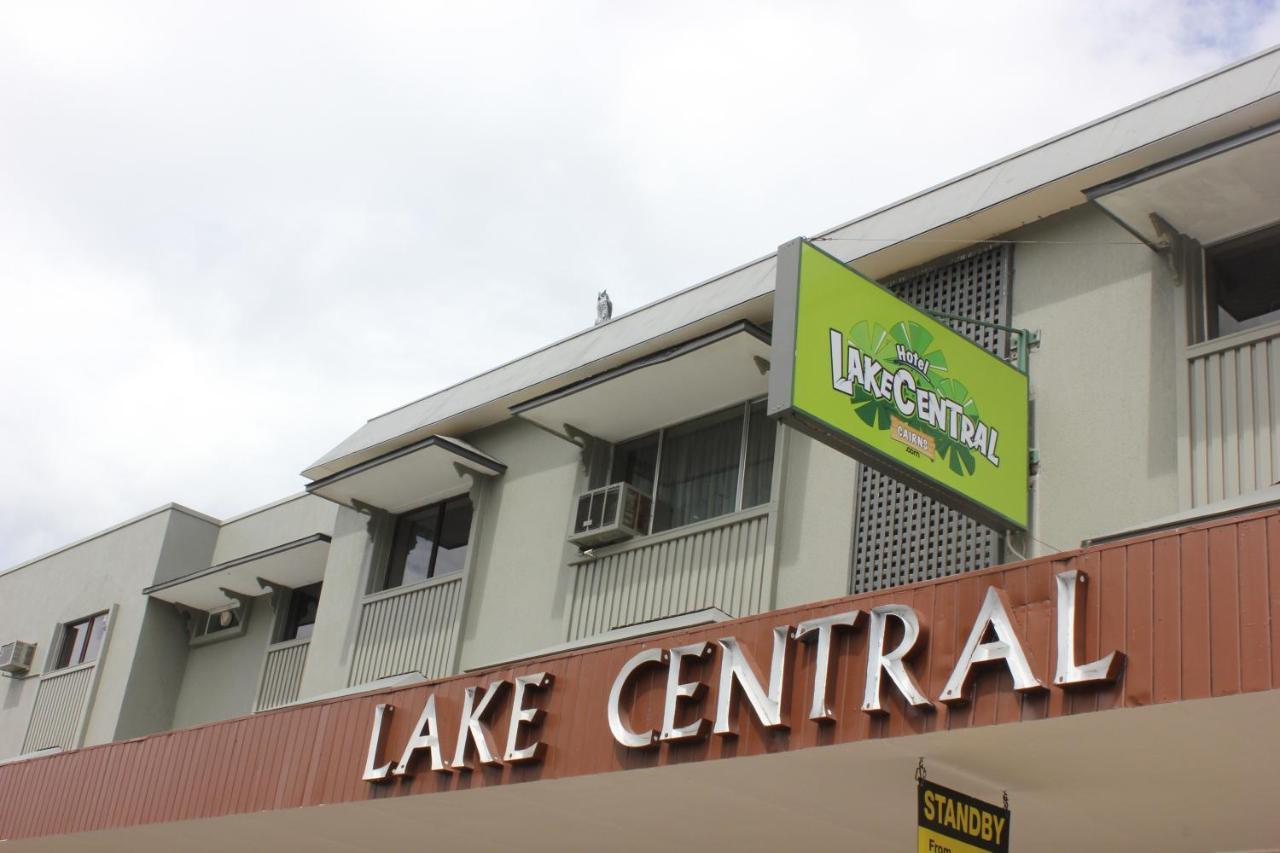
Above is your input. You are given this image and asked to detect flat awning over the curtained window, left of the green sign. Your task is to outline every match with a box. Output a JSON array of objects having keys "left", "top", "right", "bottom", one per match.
[{"left": 511, "top": 321, "right": 769, "bottom": 442}]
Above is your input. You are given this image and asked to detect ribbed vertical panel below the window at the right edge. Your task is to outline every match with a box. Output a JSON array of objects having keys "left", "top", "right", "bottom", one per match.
[{"left": 1187, "top": 329, "right": 1280, "bottom": 506}]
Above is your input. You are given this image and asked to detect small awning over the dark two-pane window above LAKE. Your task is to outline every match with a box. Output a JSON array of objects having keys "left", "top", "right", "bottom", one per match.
[{"left": 307, "top": 435, "right": 507, "bottom": 514}]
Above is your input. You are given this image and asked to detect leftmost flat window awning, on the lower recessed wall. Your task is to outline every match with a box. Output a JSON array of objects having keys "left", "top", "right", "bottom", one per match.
[{"left": 142, "top": 533, "right": 329, "bottom": 611}]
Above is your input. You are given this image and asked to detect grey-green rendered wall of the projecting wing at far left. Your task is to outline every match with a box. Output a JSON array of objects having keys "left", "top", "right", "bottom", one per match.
[{"left": 0, "top": 507, "right": 215, "bottom": 757}]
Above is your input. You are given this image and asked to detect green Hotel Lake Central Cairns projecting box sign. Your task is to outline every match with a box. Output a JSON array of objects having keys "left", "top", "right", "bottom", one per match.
[{"left": 769, "top": 240, "right": 1028, "bottom": 529}]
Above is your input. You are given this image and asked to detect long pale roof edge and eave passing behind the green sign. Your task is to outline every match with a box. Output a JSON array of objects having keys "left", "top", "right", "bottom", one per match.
[{"left": 303, "top": 49, "right": 1280, "bottom": 478}]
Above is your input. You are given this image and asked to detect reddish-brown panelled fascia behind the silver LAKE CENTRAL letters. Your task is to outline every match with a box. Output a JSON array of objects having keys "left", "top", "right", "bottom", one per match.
[{"left": 0, "top": 511, "right": 1280, "bottom": 839}]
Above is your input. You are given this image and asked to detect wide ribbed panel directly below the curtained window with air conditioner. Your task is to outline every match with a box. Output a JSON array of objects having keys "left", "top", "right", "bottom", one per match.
[{"left": 568, "top": 504, "right": 769, "bottom": 640}]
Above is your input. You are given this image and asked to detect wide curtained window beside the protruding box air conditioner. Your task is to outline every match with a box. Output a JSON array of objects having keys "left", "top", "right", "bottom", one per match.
[{"left": 608, "top": 400, "right": 776, "bottom": 533}]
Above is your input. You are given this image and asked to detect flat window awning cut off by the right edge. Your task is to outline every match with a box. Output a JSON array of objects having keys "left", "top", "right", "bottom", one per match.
[{"left": 1085, "top": 122, "right": 1280, "bottom": 246}]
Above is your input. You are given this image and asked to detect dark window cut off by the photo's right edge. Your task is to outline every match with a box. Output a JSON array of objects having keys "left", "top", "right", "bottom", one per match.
[{"left": 1204, "top": 225, "right": 1280, "bottom": 338}]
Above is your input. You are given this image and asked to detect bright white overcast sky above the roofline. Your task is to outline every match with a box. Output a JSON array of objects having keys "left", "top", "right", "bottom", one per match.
[{"left": 0, "top": 0, "right": 1280, "bottom": 567}]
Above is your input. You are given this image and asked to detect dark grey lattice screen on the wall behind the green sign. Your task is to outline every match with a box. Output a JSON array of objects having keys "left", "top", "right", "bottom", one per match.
[{"left": 852, "top": 245, "right": 1011, "bottom": 593}]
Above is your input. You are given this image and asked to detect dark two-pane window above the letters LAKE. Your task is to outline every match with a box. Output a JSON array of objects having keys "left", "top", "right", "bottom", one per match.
[{"left": 378, "top": 494, "right": 471, "bottom": 589}]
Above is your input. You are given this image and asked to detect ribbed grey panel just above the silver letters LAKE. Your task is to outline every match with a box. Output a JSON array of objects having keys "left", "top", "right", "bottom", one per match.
[{"left": 348, "top": 578, "right": 462, "bottom": 685}]
